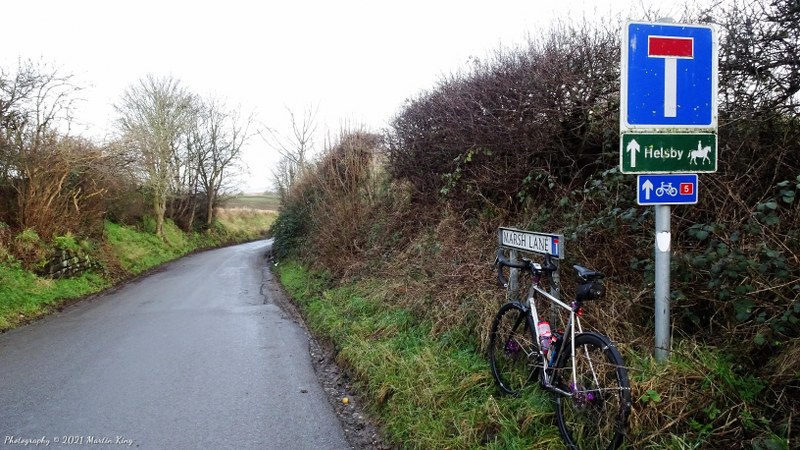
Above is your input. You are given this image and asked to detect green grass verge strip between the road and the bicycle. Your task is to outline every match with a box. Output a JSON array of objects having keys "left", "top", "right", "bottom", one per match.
[{"left": 278, "top": 262, "right": 563, "bottom": 450}]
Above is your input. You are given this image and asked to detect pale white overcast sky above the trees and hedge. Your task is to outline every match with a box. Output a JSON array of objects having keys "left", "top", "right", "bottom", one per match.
[{"left": 0, "top": 0, "right": 681, "bottom": 191}]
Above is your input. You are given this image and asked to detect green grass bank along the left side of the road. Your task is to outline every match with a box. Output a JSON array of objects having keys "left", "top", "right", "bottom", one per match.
[{"left": 0, "top": 210, "right": 275, "bottom": 332}]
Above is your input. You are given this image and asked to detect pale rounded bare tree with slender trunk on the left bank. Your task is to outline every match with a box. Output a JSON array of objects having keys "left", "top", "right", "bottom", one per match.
[{"left": 115, "top": 75, "right": 195, "bottom": 236}]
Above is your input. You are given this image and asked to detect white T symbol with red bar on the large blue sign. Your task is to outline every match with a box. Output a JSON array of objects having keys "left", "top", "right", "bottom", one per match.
[{"left": 647, "top": 36, "right": 694, "bottom": 117}]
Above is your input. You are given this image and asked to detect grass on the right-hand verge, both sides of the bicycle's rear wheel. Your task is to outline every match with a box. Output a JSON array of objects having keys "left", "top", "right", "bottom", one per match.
[{"left": 277, "top": 260, "right": 796, "bottom": 450}]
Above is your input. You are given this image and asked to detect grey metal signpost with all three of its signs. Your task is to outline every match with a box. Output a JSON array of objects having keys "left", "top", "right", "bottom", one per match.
[{"left": 619, "top": 21, "right": 719, "bottom": 361}]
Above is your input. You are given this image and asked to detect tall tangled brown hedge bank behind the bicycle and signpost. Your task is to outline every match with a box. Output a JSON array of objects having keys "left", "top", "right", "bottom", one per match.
[{"left": 273, "top": 0, "right": 800, "bottom": 449}]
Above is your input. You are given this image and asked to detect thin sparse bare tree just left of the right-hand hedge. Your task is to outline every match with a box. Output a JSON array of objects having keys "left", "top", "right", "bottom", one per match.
[{"left": 262, "top": 106, "right": 318, "bottom": 201}]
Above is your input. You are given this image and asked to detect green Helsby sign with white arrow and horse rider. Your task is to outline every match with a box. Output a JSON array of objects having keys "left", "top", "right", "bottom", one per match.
[{"left": 619, "top": 133, "right": 717, "bottom": 173}]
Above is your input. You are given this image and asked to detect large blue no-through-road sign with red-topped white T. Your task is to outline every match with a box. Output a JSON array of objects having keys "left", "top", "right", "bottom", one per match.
[{"left": 620, "top": 22, "right": 718, "bottom": 132}]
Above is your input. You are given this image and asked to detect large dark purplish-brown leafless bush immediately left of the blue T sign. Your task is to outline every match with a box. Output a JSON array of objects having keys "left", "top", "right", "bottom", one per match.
[{"left": 388, "top": 24, "right": 619, "bottom": 212}]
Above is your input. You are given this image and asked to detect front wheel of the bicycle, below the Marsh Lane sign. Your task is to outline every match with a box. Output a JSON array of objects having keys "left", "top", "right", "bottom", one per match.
[{"left": 489, "top": 302, "right": 539, "bottom": 395}]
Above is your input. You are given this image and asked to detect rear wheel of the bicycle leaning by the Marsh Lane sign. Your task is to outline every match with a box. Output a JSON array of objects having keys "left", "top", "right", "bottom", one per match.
[{"left": 554, "top": 332, "right": 631, "bottom": 450}]
